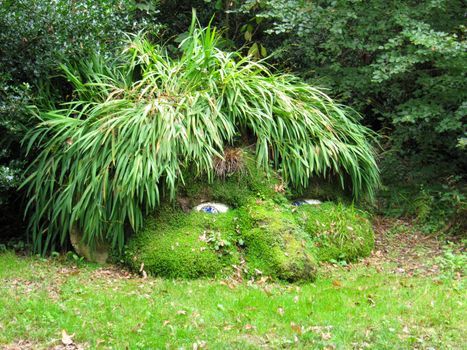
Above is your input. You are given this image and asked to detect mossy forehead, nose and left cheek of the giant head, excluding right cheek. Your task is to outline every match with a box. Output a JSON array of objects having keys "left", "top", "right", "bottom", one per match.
[{"left": 126, "top": 150, "right": 316, "bottom": 281}]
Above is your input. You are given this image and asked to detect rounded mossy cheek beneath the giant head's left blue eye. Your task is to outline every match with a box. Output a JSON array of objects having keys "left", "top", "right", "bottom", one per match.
[{"left": 126, "top": 207, "right": 238, "bottom": 278}]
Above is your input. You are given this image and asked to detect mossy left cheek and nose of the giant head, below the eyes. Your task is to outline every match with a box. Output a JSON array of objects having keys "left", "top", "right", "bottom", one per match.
[{"left": 126, "top": 200, "right": 316, "bottom": 281}]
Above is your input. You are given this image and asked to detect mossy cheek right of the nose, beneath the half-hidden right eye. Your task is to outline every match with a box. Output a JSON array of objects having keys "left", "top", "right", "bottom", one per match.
[{"left": 296, "top": 202, "right": 374, "bottom": 261}]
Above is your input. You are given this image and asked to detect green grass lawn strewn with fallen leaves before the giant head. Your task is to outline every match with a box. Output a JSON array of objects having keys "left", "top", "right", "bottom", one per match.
[{"left": 0, "top": 223, "right": 467, "bottom": 349}]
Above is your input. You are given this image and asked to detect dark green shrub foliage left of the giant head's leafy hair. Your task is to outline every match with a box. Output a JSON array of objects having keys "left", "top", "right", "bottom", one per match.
[{"left": 0, "top": 0, "right": 157, "bottom": 241}]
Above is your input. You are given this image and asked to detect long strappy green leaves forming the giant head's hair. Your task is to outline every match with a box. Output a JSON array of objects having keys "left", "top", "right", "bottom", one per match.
[{"left": 25, "top": 15, "right": 378, "bottom": 252}]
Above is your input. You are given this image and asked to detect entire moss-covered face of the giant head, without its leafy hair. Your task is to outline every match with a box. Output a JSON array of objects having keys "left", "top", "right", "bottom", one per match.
[{"left": 125, "top": 149, "right": 374, "bottom": 282}]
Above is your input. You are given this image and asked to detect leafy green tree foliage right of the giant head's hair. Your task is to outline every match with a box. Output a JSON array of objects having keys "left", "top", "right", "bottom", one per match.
[{"left": 234, "top": 0, "right": 467, "bottom": 183}]
